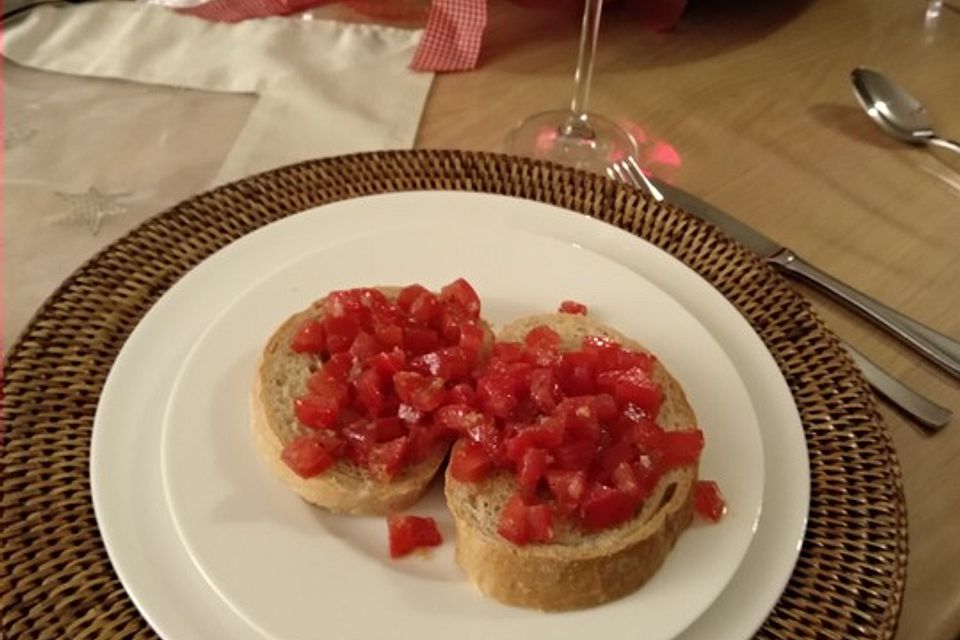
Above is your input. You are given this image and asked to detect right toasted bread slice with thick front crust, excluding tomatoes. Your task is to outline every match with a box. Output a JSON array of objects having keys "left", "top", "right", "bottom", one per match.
[{"left": 445, "top": 314, "right": 697, "bottom": 611}]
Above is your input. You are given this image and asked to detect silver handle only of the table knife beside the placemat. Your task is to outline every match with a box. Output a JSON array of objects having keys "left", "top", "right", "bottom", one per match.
[{"left": 768, "top": 249, "right": 960, "bottom": 378}]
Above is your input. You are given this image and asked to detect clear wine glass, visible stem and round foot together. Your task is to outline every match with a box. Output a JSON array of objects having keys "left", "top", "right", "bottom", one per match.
[{"left": 506, "top": 0, "right": 637, "bottom": 174}]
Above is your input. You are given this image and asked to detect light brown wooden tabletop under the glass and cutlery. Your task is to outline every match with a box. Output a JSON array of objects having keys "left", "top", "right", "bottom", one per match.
[{"left": 418, "top": 0, "right": 960, "bottom": 640}]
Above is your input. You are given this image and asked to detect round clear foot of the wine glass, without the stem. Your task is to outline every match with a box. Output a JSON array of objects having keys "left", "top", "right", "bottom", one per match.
[{"left": 506, "top": 109, "right": 638, "bottom": 175}]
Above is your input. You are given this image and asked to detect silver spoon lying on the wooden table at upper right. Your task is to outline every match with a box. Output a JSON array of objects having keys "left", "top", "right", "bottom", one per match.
[{"left": 850, "top": 67, "right": 960, "bottom": 153}]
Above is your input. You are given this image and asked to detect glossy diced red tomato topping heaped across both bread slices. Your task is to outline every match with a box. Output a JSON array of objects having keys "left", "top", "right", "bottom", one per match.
[{"left": 283, "top": 279, "right": 722, "bottom": 545}]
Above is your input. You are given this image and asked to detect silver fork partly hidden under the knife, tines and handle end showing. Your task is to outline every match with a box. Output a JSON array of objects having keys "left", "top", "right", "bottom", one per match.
[{"left": 607, "top": 156, "right": 953, "bottom": 431}]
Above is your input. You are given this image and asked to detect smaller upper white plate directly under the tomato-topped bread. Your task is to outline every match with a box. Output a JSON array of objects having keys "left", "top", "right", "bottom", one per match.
[{"left": 161, "top": 224, "right": 763, "bottom": 640}]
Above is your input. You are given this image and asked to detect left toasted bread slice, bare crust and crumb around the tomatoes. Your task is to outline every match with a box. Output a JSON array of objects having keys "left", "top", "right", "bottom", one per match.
[{"left": 251, "top": 287, "right": 492, "bottom": 515}]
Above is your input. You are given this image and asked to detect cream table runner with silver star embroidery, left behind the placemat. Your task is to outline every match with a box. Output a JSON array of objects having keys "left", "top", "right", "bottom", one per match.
[{"left": 3, "top": 2, "right": 433, "bottom": 338}]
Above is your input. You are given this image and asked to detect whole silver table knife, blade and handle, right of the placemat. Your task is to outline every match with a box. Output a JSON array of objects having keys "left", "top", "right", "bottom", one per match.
[{"left": 653, "top": 181, "right": 960, "bottom": 378}]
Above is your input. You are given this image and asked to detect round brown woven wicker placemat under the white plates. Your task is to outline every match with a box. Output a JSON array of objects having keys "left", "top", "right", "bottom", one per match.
[{"left": 0, "top": 151, "right": 907, "bottom": 640}]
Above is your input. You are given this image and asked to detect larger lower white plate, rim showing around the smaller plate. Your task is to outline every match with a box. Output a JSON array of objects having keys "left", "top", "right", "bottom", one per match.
[{"left": 91, "top": 192, "right": 809, "bottom": 640}]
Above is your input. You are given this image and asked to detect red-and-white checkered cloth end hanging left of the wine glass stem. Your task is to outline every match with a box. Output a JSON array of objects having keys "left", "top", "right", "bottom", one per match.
[{"left": 410, "top": 0, "right": 487, "bottom": 71}]
